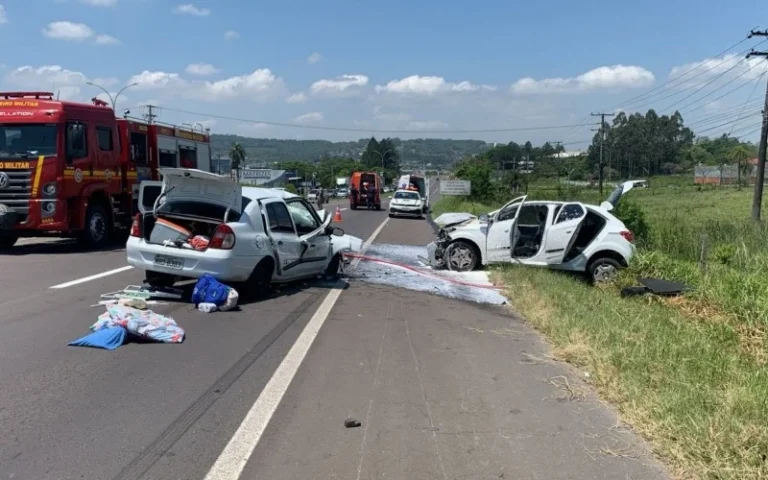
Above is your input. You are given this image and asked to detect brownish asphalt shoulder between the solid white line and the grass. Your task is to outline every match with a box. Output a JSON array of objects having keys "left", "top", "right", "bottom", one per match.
[{"left": 243, "top": 285, "right": 665, "bottom": 479}]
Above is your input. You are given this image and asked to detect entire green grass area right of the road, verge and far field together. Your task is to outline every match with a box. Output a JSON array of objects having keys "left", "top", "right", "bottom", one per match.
[{"left": 434, "top": 182, "right": 768, "bottom": 480}]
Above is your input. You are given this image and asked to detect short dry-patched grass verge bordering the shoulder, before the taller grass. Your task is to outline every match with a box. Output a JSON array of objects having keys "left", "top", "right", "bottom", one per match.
[{"left": 498, "top": 267, "right": 768, "bottom": 480}]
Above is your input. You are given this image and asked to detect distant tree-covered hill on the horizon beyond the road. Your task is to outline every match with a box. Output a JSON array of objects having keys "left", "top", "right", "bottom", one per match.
[{"left": 211, "top": 134, "right": 491, "bottom": 166}]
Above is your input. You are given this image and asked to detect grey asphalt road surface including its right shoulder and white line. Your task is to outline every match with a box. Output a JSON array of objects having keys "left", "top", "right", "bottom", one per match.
[{"left": 0, "top": 191, "right": 664, "bottom": 480}]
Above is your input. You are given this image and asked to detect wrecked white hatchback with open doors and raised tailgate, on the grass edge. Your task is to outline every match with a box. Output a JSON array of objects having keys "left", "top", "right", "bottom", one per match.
[{"left": 427, "top": 182, "right": 635, "bottom": 282}]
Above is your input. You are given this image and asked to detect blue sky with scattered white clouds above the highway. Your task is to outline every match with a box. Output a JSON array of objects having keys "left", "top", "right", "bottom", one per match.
[{"left": 0, "top": 0, "right": 768, "bottom": 149}]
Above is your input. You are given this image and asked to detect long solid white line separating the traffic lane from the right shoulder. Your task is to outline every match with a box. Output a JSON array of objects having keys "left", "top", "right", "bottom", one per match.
[{"left": 205, "top": 218, "right": 389, "bottom": 480}]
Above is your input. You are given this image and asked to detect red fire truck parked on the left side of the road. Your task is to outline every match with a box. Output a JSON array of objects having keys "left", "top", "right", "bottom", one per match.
[{"left": 0, "top": 92, "right": 211, "bottom": 249}]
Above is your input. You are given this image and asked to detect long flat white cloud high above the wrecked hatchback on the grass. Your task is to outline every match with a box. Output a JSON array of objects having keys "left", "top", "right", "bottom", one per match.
[{"left": 511, "top": 65, "right": 655, "bottom": 94}]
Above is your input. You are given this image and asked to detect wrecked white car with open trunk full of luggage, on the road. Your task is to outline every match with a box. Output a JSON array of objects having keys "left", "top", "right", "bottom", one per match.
[{"left": 126, "top": 168, "right": 363, "bottom": 288}]
